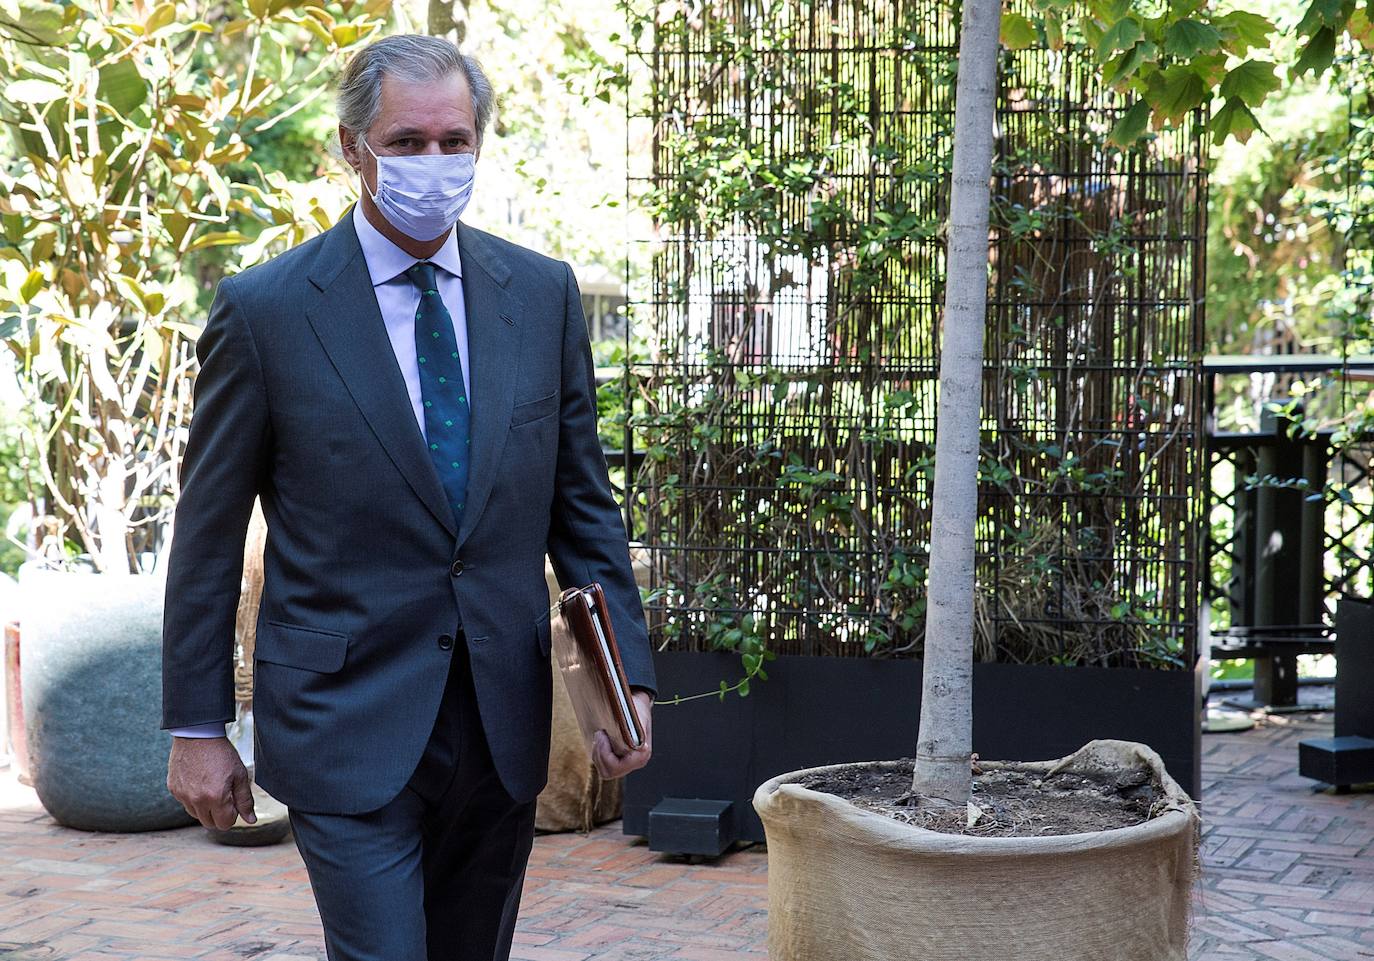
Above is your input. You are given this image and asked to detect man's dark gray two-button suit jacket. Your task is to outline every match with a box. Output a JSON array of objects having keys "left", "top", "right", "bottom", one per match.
[{"left": 162, "top": 216, "right": 654, "bottom": 814}]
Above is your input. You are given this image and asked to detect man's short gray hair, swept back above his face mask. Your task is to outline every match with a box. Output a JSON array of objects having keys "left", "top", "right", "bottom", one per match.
[{"left": 338, "top": 33, "right": 496, "bottom": 143}]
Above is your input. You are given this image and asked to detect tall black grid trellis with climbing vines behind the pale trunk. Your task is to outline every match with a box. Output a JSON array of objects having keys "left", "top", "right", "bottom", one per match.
[{"left": 629, "top": 0, "right": 1205, "bottom": 665}]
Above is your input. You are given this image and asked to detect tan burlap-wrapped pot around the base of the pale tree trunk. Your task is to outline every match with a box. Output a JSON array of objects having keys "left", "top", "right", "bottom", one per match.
[{"left": 754, "top": 741, "right": 1198, "bottom": 961}]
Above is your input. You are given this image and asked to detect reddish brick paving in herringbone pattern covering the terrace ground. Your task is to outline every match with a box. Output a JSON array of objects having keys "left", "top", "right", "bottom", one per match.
[{"left": 0, "top": 718, "right": 1374, "bottom": 961}]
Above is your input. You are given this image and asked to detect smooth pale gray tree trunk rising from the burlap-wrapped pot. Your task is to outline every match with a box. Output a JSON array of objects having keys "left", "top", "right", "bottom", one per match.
[{"left": 912, "top": 0, "right": 1002, "bottom": 804}]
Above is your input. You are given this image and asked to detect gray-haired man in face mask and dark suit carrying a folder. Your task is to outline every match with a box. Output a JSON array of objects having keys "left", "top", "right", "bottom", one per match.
[{"left": 164, "top": 36, "right": 654, "bottom": 961}]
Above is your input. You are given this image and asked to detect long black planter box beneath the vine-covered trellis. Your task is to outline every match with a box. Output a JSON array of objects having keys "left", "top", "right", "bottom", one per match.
[{"left": 624, "top": 652, "right": 1201, "bottom": 841}]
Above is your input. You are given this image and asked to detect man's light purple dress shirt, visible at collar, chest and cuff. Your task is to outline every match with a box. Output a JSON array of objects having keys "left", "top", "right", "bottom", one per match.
[{"left": 170, "top": 203, "right": 473, "bottom": 737}]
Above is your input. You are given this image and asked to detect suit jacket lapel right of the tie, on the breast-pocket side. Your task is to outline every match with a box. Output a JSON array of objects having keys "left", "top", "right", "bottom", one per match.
[{"left": 458, "top": 223, "right": 523, "bottom": 547}]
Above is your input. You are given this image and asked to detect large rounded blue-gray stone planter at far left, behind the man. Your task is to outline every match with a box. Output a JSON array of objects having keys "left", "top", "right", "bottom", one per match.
[{"left": 19, "top": 568, "right": 192, "bottom": 830}]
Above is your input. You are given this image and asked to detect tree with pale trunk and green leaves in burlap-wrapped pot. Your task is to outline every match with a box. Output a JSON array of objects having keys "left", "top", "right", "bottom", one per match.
[{"left": 754, "top": 0, "right": 1349, "bottom": 961}]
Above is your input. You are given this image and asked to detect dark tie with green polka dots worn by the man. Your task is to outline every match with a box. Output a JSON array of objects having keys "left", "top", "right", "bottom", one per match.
[{"left": 405, "top": 261, "right": 470, "bottom": 524}]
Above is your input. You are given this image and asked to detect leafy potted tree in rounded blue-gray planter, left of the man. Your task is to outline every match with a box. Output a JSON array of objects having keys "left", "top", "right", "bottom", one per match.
[{"left": 0, "top": 0, "right": 378, "bottom": 830}]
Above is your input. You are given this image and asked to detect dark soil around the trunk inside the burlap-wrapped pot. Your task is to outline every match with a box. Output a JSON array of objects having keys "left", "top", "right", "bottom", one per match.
[{"left": 798, "top": 760, "right": 1164, "bottom": 837}]
